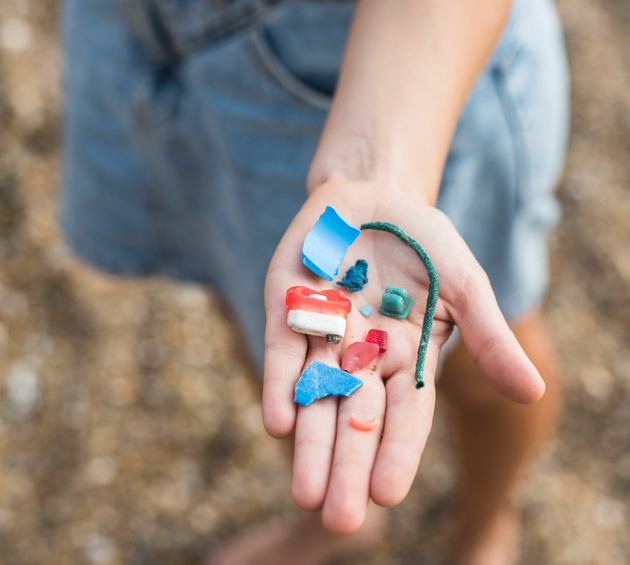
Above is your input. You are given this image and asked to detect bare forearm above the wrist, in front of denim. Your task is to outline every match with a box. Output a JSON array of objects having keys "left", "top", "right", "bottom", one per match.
[{"left": 308, "top": 0, "right": 511, "bottom": 204}]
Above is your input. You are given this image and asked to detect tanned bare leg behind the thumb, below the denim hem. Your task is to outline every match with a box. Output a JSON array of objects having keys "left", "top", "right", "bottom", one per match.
[{"left": 439, "top": 310, "right": 558, "bottom": 565}]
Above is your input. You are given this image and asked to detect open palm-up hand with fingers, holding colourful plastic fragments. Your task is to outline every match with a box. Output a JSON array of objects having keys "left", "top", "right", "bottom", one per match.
[{"left": 263, "top": 182, "right": 545, "bottom": 534}]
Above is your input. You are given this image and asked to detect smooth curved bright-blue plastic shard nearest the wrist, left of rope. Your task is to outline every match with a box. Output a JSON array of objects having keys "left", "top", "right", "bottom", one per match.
[{"left": 302, "top": 206, "right": 361, "bottom": 281}]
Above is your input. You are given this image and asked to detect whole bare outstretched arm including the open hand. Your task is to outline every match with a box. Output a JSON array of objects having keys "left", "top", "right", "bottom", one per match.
[{"left": 263, "top": 0, "right": 545, "bottom": 534}]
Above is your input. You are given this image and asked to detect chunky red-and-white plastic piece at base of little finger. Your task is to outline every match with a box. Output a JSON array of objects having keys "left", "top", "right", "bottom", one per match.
[{"left": 285, "top": 286, "right": 352, "bottom": 344}]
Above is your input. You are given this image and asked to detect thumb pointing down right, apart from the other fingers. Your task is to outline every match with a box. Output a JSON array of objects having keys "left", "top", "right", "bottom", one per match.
[{"left": 451, "top": 264, "right": 545, "bottom": 404}]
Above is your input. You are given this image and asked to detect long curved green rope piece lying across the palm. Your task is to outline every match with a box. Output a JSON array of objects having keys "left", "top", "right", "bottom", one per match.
[{"left": 361, "top": 222, "right": 440, "bottom": 389}]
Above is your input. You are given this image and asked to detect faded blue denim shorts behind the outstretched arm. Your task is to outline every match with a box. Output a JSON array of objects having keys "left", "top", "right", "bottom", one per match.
[{"left": 62, "top": 0, "right": 568, "bottom": 368}]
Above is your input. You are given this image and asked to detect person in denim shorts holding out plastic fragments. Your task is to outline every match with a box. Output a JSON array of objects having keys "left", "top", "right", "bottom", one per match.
[{"left": 63, "top": 0, "right": 567, "bottom": 565}]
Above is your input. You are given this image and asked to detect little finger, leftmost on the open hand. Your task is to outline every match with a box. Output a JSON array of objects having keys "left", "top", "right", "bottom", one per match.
[{"left": 262, "top": 276, "right": 307, "bottom": 438}]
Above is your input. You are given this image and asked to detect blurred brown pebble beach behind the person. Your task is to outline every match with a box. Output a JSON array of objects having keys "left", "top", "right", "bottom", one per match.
[{"left": 0, "top": 0, "right": 630, "bottom": 565}]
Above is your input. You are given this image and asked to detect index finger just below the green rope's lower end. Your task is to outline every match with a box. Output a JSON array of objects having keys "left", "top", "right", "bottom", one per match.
[{"left": 370, "top": 344, "right": 439, "bottom": 506}]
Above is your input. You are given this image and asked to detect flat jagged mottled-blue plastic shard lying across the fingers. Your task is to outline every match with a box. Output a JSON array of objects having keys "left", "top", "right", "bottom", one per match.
[{"left": 294, "top": 361, "right": 363, "bottom": 406}]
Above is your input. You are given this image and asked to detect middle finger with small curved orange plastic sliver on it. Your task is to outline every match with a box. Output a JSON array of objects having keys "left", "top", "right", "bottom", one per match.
[{"left": 322, "top": 368, "right": 385, "bottom": 535}]
